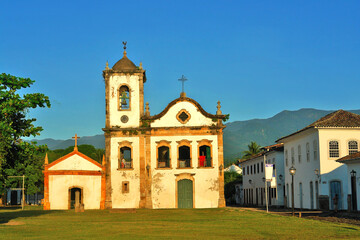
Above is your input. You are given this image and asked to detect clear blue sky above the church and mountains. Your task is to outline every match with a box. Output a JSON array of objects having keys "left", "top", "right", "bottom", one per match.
[{"left": 0, "top": 0, "right": 360, "bottom": 139}]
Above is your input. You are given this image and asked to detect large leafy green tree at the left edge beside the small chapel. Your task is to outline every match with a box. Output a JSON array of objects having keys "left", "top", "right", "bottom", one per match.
[{"left": 0, "top": 73, "right": 51, "bottom": 197}]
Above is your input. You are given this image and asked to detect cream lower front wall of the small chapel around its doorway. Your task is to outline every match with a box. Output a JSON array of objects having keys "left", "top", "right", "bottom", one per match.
[{"left": 49, "top": 175, "right": 101, "bottom": 210}]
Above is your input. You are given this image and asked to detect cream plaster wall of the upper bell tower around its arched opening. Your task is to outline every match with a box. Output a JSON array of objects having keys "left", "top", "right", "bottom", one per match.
[{"left": 109, "top": 74, "right": 140, "bottom": 128}]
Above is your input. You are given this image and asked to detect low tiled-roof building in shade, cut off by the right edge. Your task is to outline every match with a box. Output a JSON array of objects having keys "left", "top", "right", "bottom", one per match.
[{"left": 336, "top": 152, "right": 360, "bottom": 211}]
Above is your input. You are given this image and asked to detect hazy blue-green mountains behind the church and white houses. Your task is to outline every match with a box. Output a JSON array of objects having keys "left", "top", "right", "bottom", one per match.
[{"left": 28, "top": 108, "right": 360, "bottom": 165}]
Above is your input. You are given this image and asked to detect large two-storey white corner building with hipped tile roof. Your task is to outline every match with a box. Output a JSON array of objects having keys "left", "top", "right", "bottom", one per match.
[{"left": 277, "top": 110, "right": 360, "bottom": 209}]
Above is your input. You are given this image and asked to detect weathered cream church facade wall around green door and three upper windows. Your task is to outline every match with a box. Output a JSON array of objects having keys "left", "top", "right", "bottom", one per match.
[{"left": 151, "top": 135, "right": 219, "bottom": 208}]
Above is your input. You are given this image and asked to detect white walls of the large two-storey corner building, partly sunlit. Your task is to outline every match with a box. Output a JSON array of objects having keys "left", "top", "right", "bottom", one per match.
[{"left": 284, "top": 128, "right": 360, "bottom": 209}]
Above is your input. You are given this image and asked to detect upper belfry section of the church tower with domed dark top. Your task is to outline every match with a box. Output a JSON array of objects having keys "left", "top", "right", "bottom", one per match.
[{"left": 103, "top": 42, "right": 146, "bottom": 129}]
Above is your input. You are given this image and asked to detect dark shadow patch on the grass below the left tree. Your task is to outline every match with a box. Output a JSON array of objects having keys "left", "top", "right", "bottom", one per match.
[{"left": 0, "top": 207, "right": 50, "bottom": 224}]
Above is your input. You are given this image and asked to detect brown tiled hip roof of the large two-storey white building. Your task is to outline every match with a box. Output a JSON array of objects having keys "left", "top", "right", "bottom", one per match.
[{"left": 276, "top": 109, "right": 360, "bottom": 142}]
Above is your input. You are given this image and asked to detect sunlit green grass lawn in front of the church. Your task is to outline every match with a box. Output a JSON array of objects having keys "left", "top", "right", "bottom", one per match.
[{"left": 0, "top": 207, "right": 360, "bottom": 239}]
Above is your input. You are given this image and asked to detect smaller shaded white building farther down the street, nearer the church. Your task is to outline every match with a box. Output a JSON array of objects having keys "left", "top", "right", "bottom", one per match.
[{"left": 240, "top": 144, "right": 284, "bottom": 207}]
